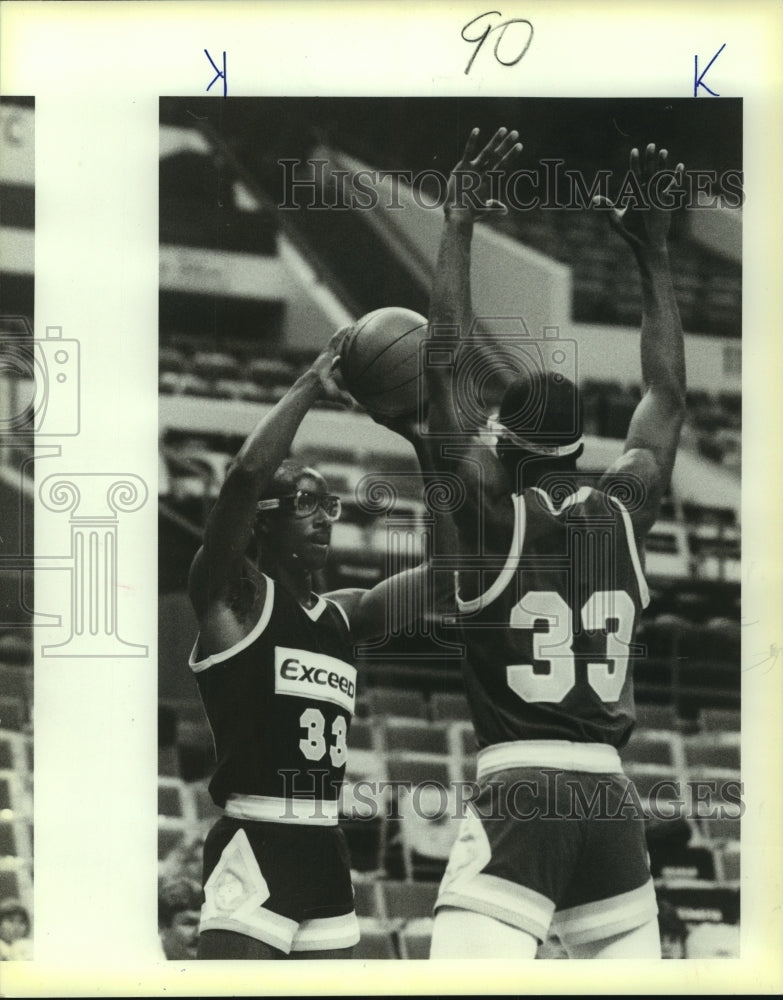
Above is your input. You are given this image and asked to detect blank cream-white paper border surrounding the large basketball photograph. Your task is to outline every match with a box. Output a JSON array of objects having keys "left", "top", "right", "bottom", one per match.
[{"left": 0, "top": 0, "right": 783, "bottom": 997}]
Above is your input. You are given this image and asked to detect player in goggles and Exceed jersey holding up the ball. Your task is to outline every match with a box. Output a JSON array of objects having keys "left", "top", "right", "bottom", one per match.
[{"left": 189, "top": 331, "right": 432, "bottom": 959}]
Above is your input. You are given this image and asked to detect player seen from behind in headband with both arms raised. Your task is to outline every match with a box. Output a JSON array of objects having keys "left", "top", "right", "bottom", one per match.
[{"left": 426, "top": 129, "right": 685, "bottom": 958}]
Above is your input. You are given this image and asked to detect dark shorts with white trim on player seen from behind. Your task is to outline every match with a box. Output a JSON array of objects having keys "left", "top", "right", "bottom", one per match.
[{"left": 435, "top": 767, "right": 658, "bottom": 946}]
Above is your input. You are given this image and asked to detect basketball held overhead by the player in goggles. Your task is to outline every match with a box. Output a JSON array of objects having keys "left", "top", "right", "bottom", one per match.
[{"left": 340, "top": 306, "right": 427, "bottom": 417}]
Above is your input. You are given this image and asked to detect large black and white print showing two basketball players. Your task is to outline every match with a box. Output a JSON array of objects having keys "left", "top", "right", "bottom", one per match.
[{"left": 158, "top": 98, "right": 744, "bottom": 959}]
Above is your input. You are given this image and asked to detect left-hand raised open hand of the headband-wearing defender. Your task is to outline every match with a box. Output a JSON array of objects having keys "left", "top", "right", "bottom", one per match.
[{"left": 443, "top": 128, "right": 522, "bottom": 220}]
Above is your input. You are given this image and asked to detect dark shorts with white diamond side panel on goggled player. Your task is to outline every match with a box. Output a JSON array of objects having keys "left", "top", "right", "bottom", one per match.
[{"left": 200, "top": 816, "right": 359, "bottom": 954}]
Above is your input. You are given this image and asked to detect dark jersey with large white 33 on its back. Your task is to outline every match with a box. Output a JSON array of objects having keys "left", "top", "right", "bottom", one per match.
[{"left": 456, "top": 487, "right": 649, "bottom": 749}]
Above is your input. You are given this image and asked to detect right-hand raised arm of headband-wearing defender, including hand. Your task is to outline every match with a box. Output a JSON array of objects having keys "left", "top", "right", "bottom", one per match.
[{"left": 602, "top": 144, "right": 685, "bottom": 539}]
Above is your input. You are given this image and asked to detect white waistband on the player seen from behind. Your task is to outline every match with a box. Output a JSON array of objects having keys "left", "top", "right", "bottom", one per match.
[{"left": 477, "top": 740, "right": 623, "bottom": 781}]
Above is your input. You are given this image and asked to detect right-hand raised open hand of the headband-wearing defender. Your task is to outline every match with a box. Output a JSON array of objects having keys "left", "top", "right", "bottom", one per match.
[{"left": 593, "top": 142, "right": 685, "bottom": 250}]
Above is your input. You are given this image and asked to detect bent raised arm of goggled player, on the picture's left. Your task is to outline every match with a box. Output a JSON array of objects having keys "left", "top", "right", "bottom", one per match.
[{"left": 190, "top": 330, "right": 350, "bottom": 610}]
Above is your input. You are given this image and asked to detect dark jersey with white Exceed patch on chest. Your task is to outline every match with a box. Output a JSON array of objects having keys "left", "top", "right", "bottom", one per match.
[{"left": 190, "top": 577, "right": 356, "bottom": 807}]
